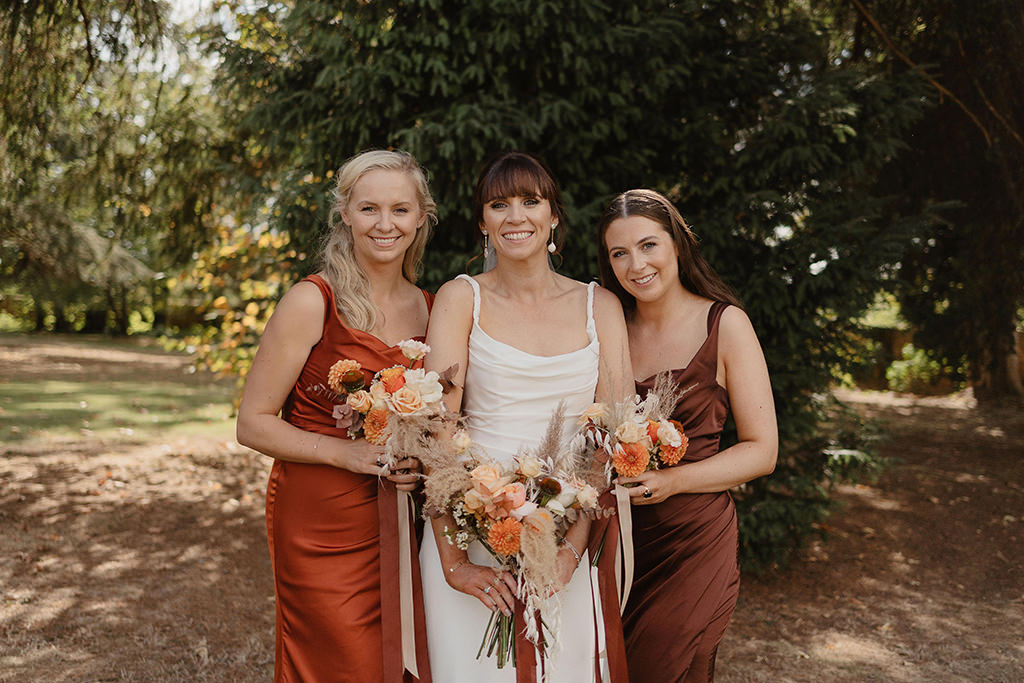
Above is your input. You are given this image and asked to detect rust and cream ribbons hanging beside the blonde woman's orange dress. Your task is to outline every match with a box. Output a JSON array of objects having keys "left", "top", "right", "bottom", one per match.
[{"left": 377, "top": 479, "right": 431, "bottom": 683}]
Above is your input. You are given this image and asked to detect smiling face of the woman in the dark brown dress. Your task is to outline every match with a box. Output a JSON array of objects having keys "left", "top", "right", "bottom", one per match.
[{"left": 604, "top": 216, "right": 682, "bottom": 302}]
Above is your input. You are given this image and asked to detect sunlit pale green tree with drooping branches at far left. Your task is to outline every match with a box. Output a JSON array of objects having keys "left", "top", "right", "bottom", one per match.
[{"left": 0, "top": 0, "right": 226, "bottom": 334}]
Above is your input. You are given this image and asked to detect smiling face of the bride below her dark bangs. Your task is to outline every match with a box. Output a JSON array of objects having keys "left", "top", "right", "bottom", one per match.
[{"left": 480, "top": 194, "right": 558, "bottom": 258}]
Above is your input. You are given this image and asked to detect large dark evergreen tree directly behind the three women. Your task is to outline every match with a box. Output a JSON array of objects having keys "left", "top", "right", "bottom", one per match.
[{"left": 208, "top": 0, "right": 922, "bottom": 561}]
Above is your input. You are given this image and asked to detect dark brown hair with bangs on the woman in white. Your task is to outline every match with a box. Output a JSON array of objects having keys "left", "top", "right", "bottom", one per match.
[{"left": 473, "top": 152, "right": 568, "bottom": 253}]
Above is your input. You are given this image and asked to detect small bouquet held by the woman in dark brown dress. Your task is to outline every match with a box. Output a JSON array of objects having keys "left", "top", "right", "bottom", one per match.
[{"left": 573, "top": 374, "right": 689, "bottom": 477}]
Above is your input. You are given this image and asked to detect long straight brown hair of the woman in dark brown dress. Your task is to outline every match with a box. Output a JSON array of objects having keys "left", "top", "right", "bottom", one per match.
[{"left": 597, "top": 189, "right": 742, "bottom": 312}]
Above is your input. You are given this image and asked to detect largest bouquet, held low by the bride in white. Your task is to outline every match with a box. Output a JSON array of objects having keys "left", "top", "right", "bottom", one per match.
[{"left": 421, "top": 404, "right": 604, "bottom": 669}]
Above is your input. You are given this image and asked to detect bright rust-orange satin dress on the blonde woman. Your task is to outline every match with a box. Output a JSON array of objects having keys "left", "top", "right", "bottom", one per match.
[{"left": 266, "top": 275, "right": 433, "bottom": 683}]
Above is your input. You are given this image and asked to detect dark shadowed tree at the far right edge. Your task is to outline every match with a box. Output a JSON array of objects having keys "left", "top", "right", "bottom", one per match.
[{"left": 842, "top": 0, "right": 1024, "bottom": 402}]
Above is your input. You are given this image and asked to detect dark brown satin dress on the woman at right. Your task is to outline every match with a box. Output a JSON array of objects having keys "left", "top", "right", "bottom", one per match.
[{"left": 623, "top": 302, "right": 739, "bottom": 683}]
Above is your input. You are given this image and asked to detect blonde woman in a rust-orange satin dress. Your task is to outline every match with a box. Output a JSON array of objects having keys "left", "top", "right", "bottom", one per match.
[{"left": 238, "top": 151, "right": 436, "bottom": 683}]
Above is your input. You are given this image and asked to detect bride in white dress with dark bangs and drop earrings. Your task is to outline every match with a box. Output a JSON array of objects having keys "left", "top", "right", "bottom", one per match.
[{"left": 420, "top": 153, "right": 632, "bottom": 683}]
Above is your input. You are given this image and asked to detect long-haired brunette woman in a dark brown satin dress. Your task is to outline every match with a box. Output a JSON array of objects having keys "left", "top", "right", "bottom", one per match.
[{"left": 598, "top": 189, "right": 778, "bottom": 683}]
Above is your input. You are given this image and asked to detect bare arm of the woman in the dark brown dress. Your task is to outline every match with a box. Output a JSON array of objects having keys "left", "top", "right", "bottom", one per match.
[{"left": 620, "top": 306, "right": 778, "bottom": 505}]
